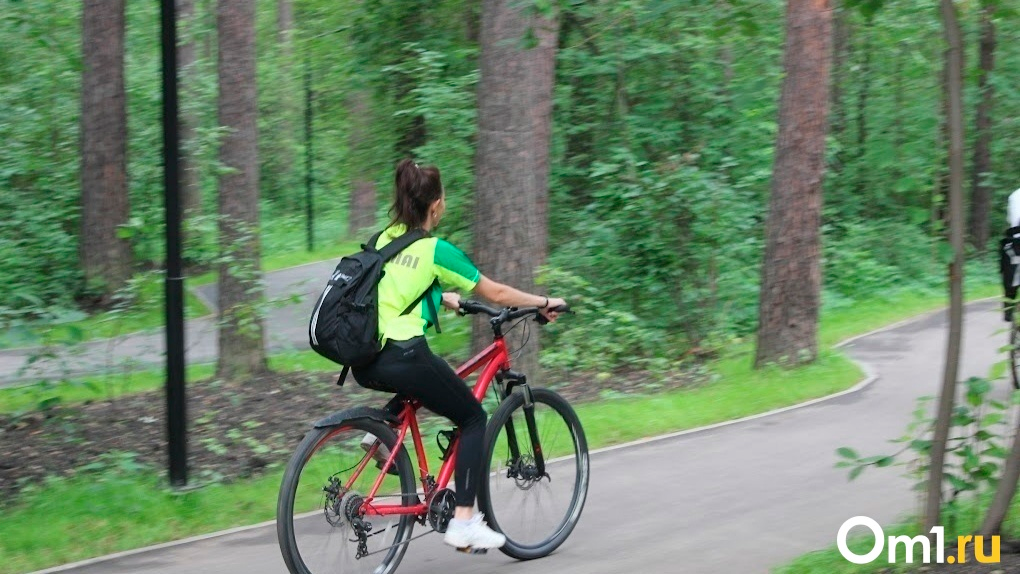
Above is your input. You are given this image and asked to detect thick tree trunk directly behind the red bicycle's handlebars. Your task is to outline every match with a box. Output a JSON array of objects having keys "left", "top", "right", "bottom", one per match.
[{"left": 473, "top": 0, "right": 559, "bottom": 376}]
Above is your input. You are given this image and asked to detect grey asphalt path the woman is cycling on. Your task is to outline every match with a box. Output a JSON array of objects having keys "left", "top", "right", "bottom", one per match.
[{"left": 31, "top": 302, "right": 1010, "bottom": 574}]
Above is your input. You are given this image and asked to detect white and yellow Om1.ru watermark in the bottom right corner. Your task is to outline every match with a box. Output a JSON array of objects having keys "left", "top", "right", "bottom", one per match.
[{"left": 835, "top": 516, "right": 999, "bottom": 564}]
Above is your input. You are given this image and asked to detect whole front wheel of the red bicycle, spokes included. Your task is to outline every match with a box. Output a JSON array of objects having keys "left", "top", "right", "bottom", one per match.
[{"left": 478, "top": 388, "right": 590, "bottom": 560}]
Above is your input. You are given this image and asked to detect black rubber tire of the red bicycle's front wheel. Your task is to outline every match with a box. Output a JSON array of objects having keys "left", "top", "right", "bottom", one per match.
[{"left": 478, "top": 388, "right": 591, "bottom": 560}]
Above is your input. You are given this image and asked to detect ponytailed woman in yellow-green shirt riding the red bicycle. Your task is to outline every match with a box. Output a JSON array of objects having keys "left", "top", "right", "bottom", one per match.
[{"left": 354, "top": 159, "right": 566, "bottom": 549}]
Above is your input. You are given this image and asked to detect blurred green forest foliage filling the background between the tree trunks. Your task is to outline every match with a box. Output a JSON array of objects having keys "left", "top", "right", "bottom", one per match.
[{"left": 0, "top": 0, "right": 1020, "bottom": 369}]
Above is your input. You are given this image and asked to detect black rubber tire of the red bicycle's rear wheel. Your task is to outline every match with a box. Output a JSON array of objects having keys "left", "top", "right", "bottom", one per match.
[{"left": 276, "top": 417, "right": 417, "bottom": 574}]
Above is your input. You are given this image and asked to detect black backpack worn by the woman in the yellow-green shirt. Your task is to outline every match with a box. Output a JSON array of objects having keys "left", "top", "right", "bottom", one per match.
[{"left": 308, "top": 229, "right": 439, "bottom": 384}]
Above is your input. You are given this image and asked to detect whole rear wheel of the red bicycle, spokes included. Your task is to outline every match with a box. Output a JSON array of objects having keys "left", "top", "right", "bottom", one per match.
[{"left": 276, "top": 418, "right": 417, "bottom": 574}]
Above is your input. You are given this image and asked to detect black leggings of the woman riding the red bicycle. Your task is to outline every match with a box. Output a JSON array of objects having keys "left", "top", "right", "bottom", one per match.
[{"left": 354, "top": 336, "right": 486, "bottom": 507}]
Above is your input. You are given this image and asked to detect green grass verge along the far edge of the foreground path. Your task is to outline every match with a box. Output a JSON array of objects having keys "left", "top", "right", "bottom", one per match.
[{"left": 0, "top": 352, "right": 860, "bottom": 574}]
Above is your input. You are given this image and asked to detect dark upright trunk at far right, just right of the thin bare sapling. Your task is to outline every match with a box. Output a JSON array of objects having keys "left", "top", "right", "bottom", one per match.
[{"left": 970, "top": 0, "right": 996, "bottom": 251}]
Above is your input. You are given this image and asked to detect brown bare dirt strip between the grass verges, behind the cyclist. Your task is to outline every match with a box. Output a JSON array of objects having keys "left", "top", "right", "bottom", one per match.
[{"left": 0, "top": 372, "right": 696, "bottom": 506}]
